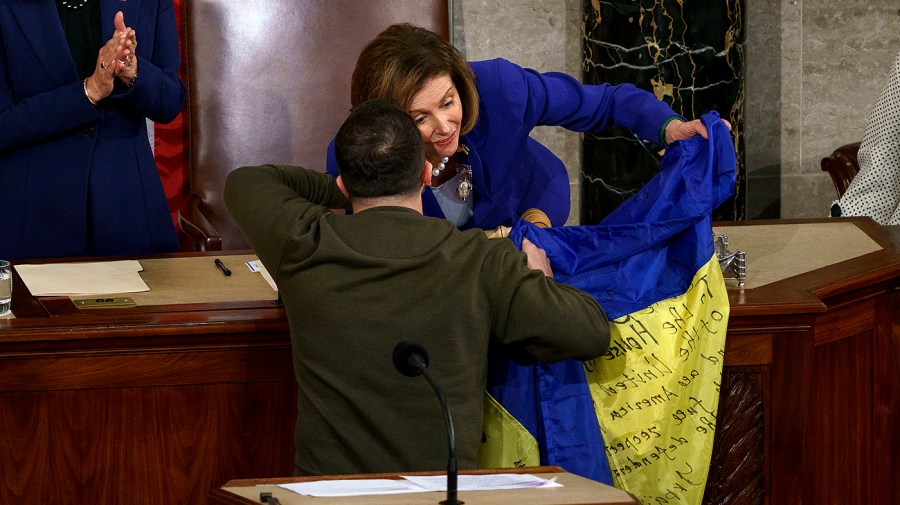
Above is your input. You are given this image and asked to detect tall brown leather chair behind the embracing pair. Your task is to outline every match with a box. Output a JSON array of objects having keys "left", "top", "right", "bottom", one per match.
[{"left": 179, "top": 0, "right": 449, "bottom": 251}]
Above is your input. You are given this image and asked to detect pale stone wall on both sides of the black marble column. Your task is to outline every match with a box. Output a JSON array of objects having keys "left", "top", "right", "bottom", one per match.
[{"left": 450, "top": 0, "right": 900, "bottom": 220}]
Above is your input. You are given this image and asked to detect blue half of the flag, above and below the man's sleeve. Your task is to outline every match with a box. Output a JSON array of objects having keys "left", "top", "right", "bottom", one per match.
[{"left": 488, "top": 112, "right": 736, "bottom": 484}]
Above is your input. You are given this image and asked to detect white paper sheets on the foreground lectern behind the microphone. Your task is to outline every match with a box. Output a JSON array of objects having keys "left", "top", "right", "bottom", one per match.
[{"left": 279, "top": 473, "right": 563, "bottom": 497}]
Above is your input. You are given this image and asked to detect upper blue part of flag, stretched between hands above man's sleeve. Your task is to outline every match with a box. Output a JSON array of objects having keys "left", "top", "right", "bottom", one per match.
[{"left": 510, "top": 112, "right": 737, "bottom": 319}]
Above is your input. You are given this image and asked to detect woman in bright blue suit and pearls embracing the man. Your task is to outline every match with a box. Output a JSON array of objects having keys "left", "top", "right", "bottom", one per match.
[{"left": 327, "top": 24, "right": 728, "bottom": 229}]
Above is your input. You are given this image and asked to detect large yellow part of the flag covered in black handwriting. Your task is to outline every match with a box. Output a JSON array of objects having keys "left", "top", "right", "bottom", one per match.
[{"left": 585, "top": 256, "right": 729, "bottom": 505}]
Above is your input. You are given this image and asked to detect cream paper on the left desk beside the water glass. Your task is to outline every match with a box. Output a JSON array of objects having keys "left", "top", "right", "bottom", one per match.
[{"left": 14, "top": 260, "right": 150, "bottom": 296}]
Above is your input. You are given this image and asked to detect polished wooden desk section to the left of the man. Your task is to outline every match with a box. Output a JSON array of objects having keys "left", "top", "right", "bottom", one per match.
[{"left": 0, "top": 254, "right": 296, "bottom": 505}]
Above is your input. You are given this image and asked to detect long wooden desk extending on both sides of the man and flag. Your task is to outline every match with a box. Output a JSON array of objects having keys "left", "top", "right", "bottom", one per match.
[{"left": 0, "top": 218, "right": 900, "bottom": 505}]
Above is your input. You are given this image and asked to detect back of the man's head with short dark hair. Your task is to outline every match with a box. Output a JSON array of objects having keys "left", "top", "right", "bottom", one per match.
[{"left": 334, "top": 98, "right": 425, "bottom": 198}]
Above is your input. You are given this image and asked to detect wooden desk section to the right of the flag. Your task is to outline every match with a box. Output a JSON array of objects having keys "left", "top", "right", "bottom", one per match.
[{"left": 704, "top": 218, "right": 900, "bottom": 504}]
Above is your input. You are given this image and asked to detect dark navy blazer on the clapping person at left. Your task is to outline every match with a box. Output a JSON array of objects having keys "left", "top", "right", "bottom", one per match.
[{"left": 0, "top": 0, "right": 185, "bottom": 259}]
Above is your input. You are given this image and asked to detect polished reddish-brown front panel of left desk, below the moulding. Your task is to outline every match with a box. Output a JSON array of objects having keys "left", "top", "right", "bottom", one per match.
[{"left": 0, "top": 383, "right": 294, "bottom": 504}]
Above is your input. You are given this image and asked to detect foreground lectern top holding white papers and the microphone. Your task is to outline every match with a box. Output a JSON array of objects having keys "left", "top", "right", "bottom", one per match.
[{"left": 209, "top": 466, "right": 638, "bottom": 505}]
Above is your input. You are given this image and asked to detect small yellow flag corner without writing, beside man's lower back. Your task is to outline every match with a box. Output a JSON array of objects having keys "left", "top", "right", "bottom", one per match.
[{"left": 478, "top": 392, "right": 541, "bottom": 468}]
